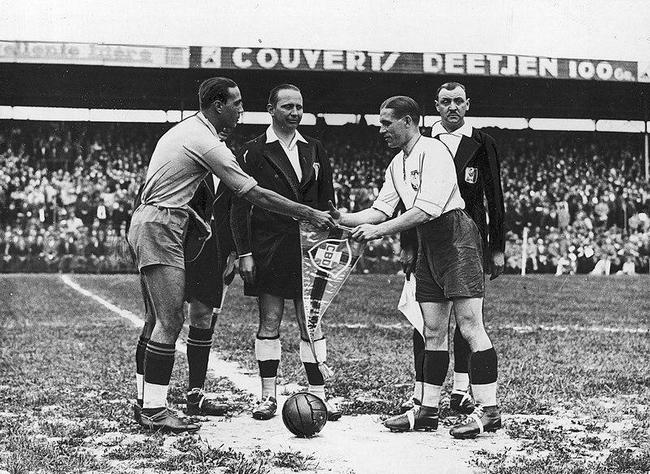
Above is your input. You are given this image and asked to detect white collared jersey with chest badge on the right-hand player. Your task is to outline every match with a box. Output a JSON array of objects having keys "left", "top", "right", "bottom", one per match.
[{"left": 372, "top": 137, "right": 465, "bottom": 219}]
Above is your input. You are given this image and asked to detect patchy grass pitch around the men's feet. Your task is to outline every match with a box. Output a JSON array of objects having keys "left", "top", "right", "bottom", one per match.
[{"left": 0, "top": 275, "right": 650, "bottom": 473}]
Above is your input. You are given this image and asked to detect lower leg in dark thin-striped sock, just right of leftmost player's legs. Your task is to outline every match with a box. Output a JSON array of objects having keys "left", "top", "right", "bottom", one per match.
[{"left": 186, "top": 298, "right": 228, "bottom": 416}]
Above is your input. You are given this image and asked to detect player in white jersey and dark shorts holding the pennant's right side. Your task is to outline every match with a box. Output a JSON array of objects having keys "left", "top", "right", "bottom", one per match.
[{"left": 332, "top": 96, "right": 501, "bottom": 438}]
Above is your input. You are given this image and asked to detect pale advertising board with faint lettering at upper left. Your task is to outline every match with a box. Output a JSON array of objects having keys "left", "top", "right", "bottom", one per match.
[{"left": 0, "top": 41, "right": 189, "bottom": 68}]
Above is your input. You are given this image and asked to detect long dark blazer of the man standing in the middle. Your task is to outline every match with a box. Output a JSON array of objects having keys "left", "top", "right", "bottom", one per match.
[{"left": 230, "top": 133, "right": 334, "bottom": 298}]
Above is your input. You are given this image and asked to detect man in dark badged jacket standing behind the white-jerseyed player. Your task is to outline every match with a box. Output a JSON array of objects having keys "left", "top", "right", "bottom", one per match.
[{"left": 401, "top": 82, "right": 505, "bottom": 422}]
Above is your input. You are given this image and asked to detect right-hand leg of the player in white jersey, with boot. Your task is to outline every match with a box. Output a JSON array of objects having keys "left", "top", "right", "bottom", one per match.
[{"left": 450, "top": 298, "right": 501, "bottom": 438}]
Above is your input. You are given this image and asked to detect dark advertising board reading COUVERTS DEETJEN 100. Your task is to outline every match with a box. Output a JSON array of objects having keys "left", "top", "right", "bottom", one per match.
[{"left": 190, "top": 47, "right": 638, "bottom": 81}]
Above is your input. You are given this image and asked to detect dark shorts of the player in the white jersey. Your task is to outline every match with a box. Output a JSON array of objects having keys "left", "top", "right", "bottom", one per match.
[{"left": 415, "top": 209, "right": 485, "bottom": 303}]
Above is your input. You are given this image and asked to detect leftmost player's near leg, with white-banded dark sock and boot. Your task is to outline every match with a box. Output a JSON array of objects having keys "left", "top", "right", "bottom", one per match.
[{"left": 140, "top": 265, "right": 199, "bottom": 432}]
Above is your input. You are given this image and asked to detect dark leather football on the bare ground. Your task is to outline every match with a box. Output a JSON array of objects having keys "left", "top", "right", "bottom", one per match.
[{"left": 282, "top": 392, "right": 327, "bottom": 438}]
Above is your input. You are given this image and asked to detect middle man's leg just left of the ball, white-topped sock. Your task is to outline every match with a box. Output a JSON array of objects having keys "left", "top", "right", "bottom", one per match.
[{"left": 253, "top": 294, "right": 284, "bottom": 420}]
